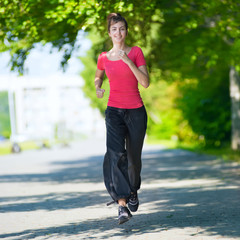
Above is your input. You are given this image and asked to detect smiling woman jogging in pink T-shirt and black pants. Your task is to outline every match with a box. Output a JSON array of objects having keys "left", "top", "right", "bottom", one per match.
[{"left": 95, "top": 13, "right": 149, "bottom": 224}]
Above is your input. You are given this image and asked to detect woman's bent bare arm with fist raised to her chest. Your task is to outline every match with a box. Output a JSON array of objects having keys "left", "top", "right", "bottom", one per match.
[{"left": 119, "top": 50, "right": 149, "bottom": 88}]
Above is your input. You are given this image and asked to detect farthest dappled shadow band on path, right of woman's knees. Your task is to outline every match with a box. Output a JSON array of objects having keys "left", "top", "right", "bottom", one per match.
[{"left": 142, "top": 149, "right": 240, "bottom": 184}]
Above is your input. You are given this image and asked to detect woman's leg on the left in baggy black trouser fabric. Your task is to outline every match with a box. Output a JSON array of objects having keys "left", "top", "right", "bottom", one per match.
[{"left": 103, "top": 107, "right": 131, "bottom": 202}]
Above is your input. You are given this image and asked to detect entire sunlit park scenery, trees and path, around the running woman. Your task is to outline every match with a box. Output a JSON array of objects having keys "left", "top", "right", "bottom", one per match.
[{"left": 0, "top": 0, "right": 240, "bottom": 240}]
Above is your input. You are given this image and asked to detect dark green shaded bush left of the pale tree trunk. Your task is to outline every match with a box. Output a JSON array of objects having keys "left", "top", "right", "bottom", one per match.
[{"left": 177, "top": 75, "right": 231, "bottom": 147}]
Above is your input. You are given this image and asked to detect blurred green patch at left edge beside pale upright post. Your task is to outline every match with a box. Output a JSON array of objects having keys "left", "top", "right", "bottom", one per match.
[{"left": 0, "top": 92, "right": 11, "bottom": 138}]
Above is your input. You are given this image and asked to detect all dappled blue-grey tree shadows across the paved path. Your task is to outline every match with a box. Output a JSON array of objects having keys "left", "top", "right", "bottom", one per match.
[{"left": 0, "top": 146, "right": 240, "bottom": 240}]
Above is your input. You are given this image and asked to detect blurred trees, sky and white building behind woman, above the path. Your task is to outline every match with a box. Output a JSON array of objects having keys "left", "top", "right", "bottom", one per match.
[{"left": 0, "top": 0, "right": 240, "bottom": 156}]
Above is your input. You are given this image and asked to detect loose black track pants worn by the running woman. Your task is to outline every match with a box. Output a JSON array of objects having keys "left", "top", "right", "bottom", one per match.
[{"left": 103, "top": 106, "right": 147, "bottom": 201}]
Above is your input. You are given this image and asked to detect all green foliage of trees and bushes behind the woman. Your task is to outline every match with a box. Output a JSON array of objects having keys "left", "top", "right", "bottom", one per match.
[{"left": 0, "top": 0, "right": 240, "bottom": 146}]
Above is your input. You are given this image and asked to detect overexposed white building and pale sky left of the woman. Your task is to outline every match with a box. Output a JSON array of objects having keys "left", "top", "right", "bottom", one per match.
[{"left": 0, "top": 31, "right": 105, "bottom": 154}]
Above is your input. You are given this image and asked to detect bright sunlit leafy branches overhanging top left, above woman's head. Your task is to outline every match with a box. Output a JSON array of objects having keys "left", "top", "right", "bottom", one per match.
[{"left": 0, "top": 0, "right": 152, "bottom": 74}]
